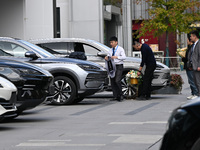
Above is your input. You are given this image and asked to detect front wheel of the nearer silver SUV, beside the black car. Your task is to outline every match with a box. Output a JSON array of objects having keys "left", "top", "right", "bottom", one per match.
[{"left": 51, "top": 76, "right": 76, "bottom": 105}]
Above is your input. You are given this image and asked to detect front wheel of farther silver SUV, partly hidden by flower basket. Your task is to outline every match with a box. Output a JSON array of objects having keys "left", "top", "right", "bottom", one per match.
[{"left": 121, "top": 75, "right": 137, "bottom": 99}]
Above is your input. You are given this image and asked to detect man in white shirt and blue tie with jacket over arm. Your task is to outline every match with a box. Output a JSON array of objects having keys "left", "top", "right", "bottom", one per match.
[{"left": 105, "top": 36, "right": 126, "bottom": 101}]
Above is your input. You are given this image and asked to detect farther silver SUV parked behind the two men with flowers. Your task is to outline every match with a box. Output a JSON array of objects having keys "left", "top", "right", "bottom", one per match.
[{"left": 30, "top": 38, "right": 170, "bottom": 95}]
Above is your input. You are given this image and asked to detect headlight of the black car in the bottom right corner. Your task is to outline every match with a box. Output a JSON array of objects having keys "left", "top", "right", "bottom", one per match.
[{"left": 168, "top": 109, "right": 188, "bottom": 129}]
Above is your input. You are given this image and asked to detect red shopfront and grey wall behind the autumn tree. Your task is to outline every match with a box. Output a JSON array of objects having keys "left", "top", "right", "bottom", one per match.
[{"left": 132, "top": 0, "right": 187, "bottom": 57}]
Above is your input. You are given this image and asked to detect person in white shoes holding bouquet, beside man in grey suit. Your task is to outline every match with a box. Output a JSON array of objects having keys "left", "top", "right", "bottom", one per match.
[{"left": 182, "top": 37, "right": 198, "bottom": 100}]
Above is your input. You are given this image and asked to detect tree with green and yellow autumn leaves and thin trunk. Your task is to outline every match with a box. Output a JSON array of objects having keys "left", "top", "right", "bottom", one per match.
[{"left": 137, "top": 0, "right": 200, "bottom": 66}]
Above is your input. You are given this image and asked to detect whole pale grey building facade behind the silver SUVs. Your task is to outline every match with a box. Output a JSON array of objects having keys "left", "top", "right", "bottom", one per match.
[{"left": 0, "top": 0, "right": 123, "bottom": 44}]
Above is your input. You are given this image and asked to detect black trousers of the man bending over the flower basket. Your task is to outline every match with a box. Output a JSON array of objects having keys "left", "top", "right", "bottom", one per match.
[{"left": 140, "top": 65, "right": 156, "bottom": 97}]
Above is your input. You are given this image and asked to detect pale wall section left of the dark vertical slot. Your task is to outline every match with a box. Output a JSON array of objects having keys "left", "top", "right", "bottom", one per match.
[{"left": 0, "top": 0, "right": 53, "bottom": 40}]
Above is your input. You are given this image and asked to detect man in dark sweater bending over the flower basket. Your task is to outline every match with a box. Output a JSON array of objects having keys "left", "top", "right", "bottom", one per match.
[{"left": 133, "top": 41, "right": 156, "bottom": 100}]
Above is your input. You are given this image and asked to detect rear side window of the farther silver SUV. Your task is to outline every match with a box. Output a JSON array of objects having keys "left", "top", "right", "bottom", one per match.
[{"left": 40, "top": 42, "right": 74, "bottom": 55}]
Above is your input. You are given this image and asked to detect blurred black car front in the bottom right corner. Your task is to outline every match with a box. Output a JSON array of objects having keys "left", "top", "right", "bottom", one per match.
[{"left": 160, "top": 98, "right": 200, "bottom": 150}]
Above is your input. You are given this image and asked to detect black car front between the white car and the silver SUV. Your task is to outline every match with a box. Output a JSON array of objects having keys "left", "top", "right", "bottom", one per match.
[{"left": 0, "top": 58, "right": 54, "bottom": 114}]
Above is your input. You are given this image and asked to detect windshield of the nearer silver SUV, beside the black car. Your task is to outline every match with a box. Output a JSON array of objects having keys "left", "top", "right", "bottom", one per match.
[{"left": 19, "top": 40, "right": 55, "bottom": 58}]
